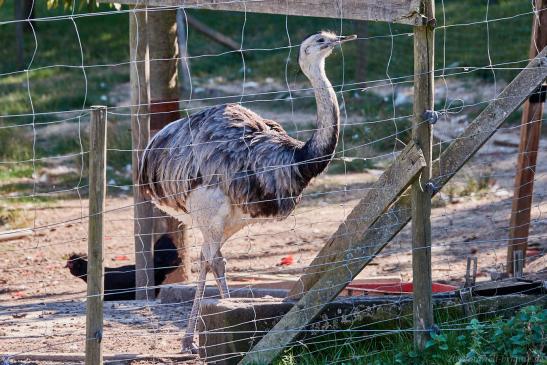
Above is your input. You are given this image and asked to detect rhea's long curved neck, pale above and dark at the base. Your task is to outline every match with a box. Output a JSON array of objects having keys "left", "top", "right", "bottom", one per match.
[{"left": 297, "top": 63, "right": 340, "bottom": 179}]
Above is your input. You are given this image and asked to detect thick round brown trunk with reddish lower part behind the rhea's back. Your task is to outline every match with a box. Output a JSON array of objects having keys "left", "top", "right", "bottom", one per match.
[{"left": 148, "top": 10, "right": 190, "bottom": 285}]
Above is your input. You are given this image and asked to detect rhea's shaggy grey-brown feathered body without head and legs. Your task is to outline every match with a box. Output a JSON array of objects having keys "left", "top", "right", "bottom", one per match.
[{"left": 140, "top": 104, "right": 338, "bottom": 218}]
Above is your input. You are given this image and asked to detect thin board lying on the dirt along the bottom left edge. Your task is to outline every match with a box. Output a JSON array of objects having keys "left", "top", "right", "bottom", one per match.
[{"left": 0, "top": 352, "right": 197, "bottom": 364}]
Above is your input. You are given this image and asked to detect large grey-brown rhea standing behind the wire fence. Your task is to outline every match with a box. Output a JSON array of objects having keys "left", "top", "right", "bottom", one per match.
[{"left": 139, "top": 31, "right": 356, "bottom": 352}]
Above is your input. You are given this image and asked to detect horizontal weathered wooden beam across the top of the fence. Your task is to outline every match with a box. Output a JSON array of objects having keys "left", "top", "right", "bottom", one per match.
[{"left": 104, "top": 0, "right": 426, "bottom": 25}]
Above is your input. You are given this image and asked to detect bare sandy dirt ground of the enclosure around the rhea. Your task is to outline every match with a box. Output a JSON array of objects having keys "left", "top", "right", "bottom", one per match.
[{"left": 0, "top": 124, "right": 547, "bottom": 364}]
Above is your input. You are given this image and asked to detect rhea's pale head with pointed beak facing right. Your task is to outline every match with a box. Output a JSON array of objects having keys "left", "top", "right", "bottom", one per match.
[{"left": 298, "top": 31, "right": 357, "bottom": 77}]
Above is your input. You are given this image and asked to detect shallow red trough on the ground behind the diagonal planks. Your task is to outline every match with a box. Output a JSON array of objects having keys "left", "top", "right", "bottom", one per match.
[{"left": 346, "top": 280, "right": 458, "bottom": 296}]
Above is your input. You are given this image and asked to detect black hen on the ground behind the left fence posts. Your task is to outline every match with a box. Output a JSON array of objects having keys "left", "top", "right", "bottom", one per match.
[{"left": 65, "top": 234, "right": 181, "bottom": 301}]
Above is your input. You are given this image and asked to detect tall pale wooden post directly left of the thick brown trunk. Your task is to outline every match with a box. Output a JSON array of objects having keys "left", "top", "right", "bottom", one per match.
[{"left": 129, "top": 7, "right": 155, "bottom": 300}]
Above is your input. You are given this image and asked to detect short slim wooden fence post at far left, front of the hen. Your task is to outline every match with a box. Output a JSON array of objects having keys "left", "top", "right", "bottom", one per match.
[{"left": 85, "top": 106, "right": 106, "bottom": 365}]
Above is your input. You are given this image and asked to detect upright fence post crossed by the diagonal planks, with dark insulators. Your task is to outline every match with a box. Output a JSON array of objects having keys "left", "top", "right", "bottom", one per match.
[{"left": 412, "top": 0, "right": 435, "bottom": 350}]
